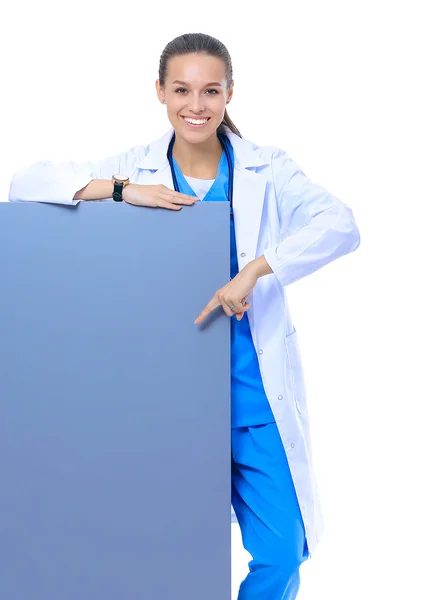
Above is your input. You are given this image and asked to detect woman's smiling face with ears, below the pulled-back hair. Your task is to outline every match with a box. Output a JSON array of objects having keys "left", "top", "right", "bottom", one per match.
[{"left": 156, "top": 54, "right": 233, "bottom": 144}]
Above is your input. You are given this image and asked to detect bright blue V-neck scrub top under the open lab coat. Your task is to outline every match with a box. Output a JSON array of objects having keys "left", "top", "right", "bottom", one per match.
[{"left": 172, "top": 136, "right": 275, "bottom": 427}]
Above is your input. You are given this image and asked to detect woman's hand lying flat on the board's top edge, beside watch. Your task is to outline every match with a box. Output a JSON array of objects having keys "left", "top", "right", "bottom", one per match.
[{"left": 123, "top": 183, "right": 199, "bottom": 210}]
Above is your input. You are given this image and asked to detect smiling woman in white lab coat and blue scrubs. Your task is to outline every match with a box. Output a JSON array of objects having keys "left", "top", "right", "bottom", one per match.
[{"left": 10, "top": 34, "right": 360, "bottom": 600}]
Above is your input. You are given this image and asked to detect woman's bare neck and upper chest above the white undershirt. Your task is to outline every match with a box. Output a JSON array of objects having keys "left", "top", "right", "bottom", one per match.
[{"left": 172, "top": 133, "right": 223, "bottom": 179}]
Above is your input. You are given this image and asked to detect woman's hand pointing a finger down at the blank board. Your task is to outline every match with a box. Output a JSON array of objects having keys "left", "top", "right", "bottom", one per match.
[{"left": 194, "top": 264, "right": 258, "bottom": 325}]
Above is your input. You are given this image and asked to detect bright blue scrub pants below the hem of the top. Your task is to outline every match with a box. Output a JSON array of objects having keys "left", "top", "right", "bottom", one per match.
[{"left": 231, "top": 423, "right": 308, "bottom": 600}]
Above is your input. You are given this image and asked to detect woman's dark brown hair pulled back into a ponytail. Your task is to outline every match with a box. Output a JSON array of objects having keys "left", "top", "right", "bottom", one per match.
[{"left": 158, "top": 33, "right": 242, "bottom": 137}]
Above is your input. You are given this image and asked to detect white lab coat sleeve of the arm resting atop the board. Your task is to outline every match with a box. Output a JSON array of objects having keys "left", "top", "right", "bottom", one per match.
[{"left": 9, "top": 145, "right": 146, "bottom": 205}]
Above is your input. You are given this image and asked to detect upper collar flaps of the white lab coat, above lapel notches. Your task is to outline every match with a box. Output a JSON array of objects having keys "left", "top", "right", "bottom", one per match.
[{"left": 137, "top": 127, "right": 269, "bottom": 171}]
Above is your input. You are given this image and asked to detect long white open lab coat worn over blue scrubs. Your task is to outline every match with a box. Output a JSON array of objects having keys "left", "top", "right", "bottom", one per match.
[{"left": 9, "top": 128, "right": 360, "bottom": 557}]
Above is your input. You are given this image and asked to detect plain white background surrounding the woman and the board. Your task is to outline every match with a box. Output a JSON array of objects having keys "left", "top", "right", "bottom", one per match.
[{"left": 0, "top": 0, "right": 442, "bottom": 600}]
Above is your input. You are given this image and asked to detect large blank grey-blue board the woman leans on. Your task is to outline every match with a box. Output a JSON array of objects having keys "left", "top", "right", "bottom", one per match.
[{"left": 0, "top": 202, "right": 231, "bottom": 600}]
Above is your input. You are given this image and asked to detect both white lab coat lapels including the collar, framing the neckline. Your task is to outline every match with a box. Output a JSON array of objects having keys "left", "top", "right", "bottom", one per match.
[{"left": 138, "top": 129, "right": 268, "bottom": 262}]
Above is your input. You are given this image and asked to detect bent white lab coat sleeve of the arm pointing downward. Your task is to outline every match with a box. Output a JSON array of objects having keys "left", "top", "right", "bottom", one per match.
[{"left": 264, "top": 149, "right": 360, "bottom": 286}]
